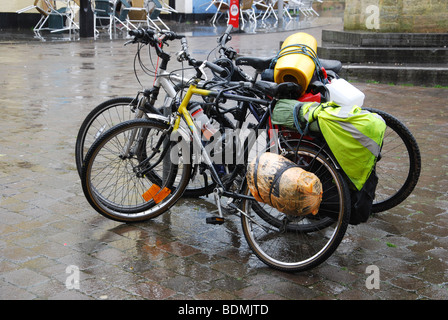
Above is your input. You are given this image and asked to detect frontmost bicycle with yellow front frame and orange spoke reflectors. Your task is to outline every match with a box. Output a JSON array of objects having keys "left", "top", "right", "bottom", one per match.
[{"left": 81, "top": 31, "right": 350, "bottom": 271}]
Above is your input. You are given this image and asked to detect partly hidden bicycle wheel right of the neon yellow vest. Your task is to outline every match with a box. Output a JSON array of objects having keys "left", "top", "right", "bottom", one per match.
[{"left": 364, "top": 108, "right": 421, "bottom": 212}]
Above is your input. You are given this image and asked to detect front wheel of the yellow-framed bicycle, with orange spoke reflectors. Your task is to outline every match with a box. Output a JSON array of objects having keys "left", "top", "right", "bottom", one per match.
[{"left": 81, "top": 119, "right": 191, "bottom": 222}]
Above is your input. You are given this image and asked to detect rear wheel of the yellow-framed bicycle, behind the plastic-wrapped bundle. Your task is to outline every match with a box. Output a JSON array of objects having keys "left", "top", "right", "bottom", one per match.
[{"left": 241, "top": 148, "right": 350, "bottom": 272}]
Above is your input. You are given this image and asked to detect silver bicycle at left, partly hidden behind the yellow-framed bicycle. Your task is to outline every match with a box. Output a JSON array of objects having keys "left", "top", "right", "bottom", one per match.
[{"left": 75, "top": 29, "right": 217, "bottom": 196}]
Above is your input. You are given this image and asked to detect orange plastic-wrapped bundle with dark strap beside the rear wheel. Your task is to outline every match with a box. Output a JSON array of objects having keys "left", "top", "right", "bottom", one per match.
[{"left": 246, "top": 152, "right": 322, "bottom": 216}]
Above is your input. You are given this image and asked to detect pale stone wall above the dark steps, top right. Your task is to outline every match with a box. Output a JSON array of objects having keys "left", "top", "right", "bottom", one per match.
[{"left": 344, "top": 0, "right": 448, "bottom": 33}]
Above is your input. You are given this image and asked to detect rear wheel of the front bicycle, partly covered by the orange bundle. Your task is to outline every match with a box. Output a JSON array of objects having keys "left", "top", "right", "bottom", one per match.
[{"left": 241, "top": 148, "right": 351, "bottom": 272}]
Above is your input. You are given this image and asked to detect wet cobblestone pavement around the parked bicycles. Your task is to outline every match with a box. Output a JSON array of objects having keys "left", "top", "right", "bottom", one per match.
[{"left": 0, "top": 19, "right": 448, "bottom": 300}]
